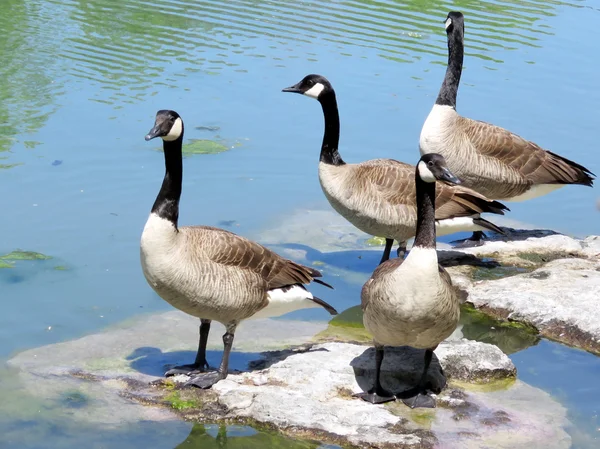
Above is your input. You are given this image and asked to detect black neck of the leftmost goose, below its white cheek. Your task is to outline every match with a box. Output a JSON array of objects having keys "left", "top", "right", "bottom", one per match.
[{"left": 152, "top": 134, "right": 183, "bottom": 228}]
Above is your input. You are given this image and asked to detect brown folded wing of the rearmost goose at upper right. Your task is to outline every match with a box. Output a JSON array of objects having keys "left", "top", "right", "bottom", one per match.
[{"left": 458, "top": 117, "right": 594, "bottom": 186}]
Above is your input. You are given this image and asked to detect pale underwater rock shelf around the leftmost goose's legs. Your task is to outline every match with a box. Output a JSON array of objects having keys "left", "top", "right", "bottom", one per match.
[{"left": 7, "top": 311, "right": 327, "bottom": 425}]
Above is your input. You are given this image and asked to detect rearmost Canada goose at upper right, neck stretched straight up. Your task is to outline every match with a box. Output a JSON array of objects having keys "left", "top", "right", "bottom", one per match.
[{"left": 419, "top": 12, "right": 595, "bottom": 201}]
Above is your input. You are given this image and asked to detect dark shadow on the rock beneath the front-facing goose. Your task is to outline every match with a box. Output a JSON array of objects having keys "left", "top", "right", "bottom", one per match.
[{"left": 350, "top": 346, "right": 446, "bottom": 397}]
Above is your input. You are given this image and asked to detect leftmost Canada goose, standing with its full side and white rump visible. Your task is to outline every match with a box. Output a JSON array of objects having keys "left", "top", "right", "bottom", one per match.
[{"left": 140, "top": 110, "right": 337, "bottom": 388}]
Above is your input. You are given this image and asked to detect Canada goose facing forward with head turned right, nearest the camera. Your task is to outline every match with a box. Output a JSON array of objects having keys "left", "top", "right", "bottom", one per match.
[{"left": 357, "top": 154, "right": 460, "bottom": 408}]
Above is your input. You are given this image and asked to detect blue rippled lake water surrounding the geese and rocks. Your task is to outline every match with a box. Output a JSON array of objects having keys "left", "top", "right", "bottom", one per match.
[{"left": 0, "top": 0, "right": 600, "bottom": 448}]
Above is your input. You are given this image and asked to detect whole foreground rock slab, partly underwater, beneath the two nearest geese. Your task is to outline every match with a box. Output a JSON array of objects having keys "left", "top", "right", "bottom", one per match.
[{"left": 7, "top": 311, "right": 570, "bottom": 448}]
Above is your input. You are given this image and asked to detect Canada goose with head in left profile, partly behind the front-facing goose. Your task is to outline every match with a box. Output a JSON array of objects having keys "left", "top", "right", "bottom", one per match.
[{"left": 283, "top": 75, "right": 507, "bottom": 262}]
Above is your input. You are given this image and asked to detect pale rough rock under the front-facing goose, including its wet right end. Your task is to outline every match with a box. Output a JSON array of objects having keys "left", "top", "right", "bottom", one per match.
[{"left": 213, "top": 340, "right": 571, "bottom": 448}]
